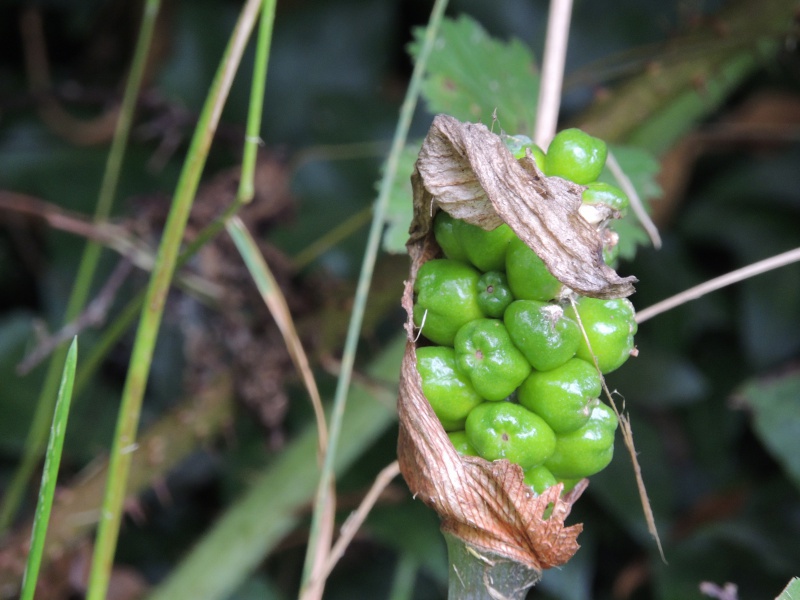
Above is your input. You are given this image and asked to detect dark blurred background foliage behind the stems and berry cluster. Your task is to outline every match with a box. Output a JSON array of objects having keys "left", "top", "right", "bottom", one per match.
[{"left": 0, "top": 0, "right": 800, "bottom": 600}]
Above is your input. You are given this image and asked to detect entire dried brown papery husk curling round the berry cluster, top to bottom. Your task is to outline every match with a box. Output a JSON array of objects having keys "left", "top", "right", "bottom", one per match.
[{"left": 398, "top": 115, "right": 635, "bottom": 570}]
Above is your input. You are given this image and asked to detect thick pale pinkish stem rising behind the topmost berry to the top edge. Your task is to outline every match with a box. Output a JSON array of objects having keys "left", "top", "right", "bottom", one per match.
[{"left": 534, "top": 0, "right": 572, "bottom": 149}]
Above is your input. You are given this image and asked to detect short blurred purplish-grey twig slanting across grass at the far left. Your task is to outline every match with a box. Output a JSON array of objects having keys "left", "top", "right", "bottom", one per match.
[{"left": 17, "top": 259, "right": 133, "bottom": 375}]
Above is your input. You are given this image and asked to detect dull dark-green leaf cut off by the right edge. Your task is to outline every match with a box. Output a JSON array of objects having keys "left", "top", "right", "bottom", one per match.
[{"left": 737, "top": 371, "right": 800, "bottom": 489}]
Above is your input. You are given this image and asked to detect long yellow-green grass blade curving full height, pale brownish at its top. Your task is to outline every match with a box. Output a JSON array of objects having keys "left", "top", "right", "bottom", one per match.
[{"left": 87, "top": 0, "right": 261, "bottom": 600}]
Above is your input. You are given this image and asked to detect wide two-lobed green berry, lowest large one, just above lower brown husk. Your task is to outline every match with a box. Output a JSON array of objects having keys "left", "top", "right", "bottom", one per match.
[{"left": 465, "top": 402, "right": 556, "bottom": 469}]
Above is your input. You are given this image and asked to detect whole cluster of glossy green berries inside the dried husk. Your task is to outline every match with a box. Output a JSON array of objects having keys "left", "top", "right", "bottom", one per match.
[{"left": 413, "top": 129, "right": 636, "bottom": 494}]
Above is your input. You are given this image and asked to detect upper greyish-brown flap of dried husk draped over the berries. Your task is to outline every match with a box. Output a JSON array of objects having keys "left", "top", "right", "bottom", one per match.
[{"left": 409, "top": 115, "right": 636, "bottom": 298}]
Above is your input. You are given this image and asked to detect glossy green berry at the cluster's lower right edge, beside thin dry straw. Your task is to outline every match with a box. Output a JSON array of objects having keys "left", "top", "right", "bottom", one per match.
[{"left": 544, "top": 400, "right": 617, "bottom": 479}]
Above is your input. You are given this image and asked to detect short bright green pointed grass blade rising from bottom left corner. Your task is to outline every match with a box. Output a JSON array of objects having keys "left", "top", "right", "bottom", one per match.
[{"left": 20, "top": 337, "right": 78, "bottom": 600}]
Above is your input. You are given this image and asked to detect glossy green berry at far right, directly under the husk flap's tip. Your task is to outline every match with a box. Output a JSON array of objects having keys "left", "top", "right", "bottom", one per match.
[{"left": 568, "top": 297, "right": 637, "bottom": 373}]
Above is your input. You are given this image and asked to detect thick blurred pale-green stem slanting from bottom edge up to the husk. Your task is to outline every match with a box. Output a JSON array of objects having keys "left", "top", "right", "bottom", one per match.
[{"left": 148, "top": 334, "right": 406, "bottom": 600}]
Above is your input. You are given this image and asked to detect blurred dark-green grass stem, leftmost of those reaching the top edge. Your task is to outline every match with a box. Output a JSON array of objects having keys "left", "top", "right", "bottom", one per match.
[{"left": 0, "top": 0, "right": 161, "bottom": 532}]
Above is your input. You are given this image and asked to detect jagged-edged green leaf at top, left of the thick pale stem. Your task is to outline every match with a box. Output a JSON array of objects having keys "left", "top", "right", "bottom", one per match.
[{"left": 409, "top": 15, "right": 539, "bottom": 135}]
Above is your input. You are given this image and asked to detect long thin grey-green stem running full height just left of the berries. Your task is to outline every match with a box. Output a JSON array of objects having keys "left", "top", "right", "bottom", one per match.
[{"left": 300, "top": 0, "right": 447, "bottom": 597}]
